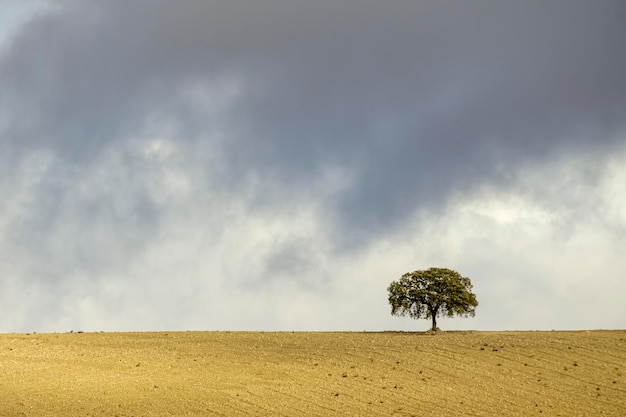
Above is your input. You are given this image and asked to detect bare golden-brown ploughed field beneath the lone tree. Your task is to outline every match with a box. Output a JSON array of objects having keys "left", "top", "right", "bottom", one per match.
[{"left": 0, "top": 331, "right": 626, "bottom": 416}]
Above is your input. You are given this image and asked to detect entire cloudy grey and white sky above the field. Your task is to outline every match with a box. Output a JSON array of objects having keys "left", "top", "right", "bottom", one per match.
[{"left": 0, "top": 0, "right": 626, "bottom": 332}]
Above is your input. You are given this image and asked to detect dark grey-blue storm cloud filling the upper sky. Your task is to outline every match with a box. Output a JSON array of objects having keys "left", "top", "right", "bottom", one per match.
[{"left": 0, "top": 0, "right": 626, "bottom": 250}]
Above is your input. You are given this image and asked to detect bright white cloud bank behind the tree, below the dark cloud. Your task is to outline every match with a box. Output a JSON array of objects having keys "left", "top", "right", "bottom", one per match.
[{"left": 0, "top": 139, "right": 626, "bottom": 331}]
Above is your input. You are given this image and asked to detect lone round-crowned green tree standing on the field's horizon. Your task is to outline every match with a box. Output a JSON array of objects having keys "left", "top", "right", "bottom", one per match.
[{"left": 387, "top": 268, "right": 478, "bottom": 331}]
